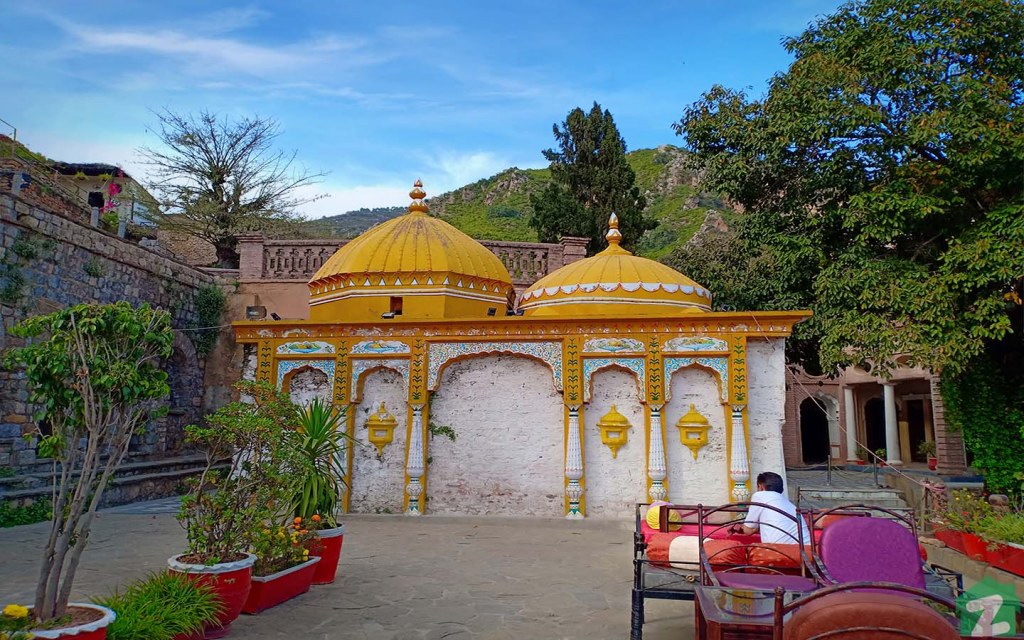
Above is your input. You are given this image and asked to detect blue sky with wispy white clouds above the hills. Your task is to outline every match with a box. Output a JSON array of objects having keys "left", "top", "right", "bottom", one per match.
[{"left": 0, "top": 0, "right": 840, "bottom": 217}]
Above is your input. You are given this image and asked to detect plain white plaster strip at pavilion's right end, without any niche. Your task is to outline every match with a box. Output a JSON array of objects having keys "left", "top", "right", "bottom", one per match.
[{"left": 746, "top": 338, "right": 785, "bottom": 489}]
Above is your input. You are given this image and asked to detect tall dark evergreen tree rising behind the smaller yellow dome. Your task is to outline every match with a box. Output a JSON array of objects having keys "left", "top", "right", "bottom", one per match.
[{"left": 530, "top": 102, "right": 656, "bottom": 253}]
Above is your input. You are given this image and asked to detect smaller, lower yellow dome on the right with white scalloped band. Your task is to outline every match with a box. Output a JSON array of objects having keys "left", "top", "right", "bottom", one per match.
[{"left": 519, "top": 214, "right": 711, "bottom": 317}]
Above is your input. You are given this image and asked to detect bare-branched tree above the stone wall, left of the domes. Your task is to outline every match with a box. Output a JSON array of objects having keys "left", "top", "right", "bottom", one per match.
[{"left": 139, "top": 110, "right": 325, "bottom": 267}]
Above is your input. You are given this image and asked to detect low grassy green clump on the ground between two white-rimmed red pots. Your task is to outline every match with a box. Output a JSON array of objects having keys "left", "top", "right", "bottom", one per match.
[{"left": 95, "top": 573, "right": 221, "bottom": 640}]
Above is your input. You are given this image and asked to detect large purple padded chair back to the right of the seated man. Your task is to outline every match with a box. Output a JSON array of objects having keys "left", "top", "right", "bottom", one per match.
[{"left": 820, "top": 518, "right": 925, "bottom": 589}]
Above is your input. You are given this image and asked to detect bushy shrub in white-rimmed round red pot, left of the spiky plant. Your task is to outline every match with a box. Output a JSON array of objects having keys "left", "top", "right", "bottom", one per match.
[{"left": 168, "top": 381, "right": 296, "bottom": 638}]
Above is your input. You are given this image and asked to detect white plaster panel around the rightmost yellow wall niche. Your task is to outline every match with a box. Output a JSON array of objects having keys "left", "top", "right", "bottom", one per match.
[{"left": 664, "top": 367, "right": 729, "bottom": 505}]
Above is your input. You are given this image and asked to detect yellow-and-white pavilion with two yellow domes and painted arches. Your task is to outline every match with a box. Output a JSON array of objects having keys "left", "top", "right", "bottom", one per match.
[{"left": 234, "top": 181, "right": 810, "bottom": 518}]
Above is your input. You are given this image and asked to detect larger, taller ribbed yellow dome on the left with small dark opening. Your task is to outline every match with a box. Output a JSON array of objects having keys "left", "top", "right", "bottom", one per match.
[{"left": 309, "top": 180, "right": 512, "bottom": 322}]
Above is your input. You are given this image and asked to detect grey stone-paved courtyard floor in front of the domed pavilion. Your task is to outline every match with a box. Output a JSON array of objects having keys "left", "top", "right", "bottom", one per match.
[{"left": 0, "top": 501, "right": 693, "bottom": 640}]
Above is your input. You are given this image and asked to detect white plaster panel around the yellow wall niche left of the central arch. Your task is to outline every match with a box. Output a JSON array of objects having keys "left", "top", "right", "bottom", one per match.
[{"left": 349, "top": 369, "right": 409, "bottom": 513}]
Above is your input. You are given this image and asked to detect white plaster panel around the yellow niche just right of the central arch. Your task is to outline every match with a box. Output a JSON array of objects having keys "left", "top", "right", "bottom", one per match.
[{"left": 583, "top": 369, "right": 647, "bottom": 517}]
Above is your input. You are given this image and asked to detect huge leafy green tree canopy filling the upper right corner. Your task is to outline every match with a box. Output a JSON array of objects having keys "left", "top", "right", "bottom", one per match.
[{"left": 675, "top": 0, "right": 1024, "bottom": 375}]
